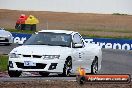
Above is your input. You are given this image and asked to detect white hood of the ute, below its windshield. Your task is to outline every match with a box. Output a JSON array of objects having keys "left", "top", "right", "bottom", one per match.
[{"left": 11, "top": 45, "right": 70, "bottom": 55}]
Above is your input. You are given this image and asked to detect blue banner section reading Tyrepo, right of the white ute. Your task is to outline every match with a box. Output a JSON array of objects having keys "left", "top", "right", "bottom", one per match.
[{"left": 85, "top": 37, "right": 132, "bottom": 50}]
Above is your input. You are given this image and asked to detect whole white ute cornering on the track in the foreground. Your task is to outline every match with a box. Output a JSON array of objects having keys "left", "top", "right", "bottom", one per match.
[{"left": 8, "top": 30, "right": 102, "bottom": 77}]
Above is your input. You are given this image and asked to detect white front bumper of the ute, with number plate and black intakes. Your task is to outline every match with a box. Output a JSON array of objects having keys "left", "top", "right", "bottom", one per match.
[{"left": 8, "top": 58, "right": 65, "bottom": 73}]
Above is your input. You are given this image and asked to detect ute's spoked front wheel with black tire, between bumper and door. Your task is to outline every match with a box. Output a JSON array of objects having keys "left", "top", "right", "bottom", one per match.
[{"left": 62, "top": 58, "right": 72, "bottom": 77}]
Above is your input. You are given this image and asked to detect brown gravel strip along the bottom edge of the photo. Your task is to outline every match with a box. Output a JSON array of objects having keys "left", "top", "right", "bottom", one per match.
[{"left": 0, "top": 80, "right": 132, "bottom": 88}]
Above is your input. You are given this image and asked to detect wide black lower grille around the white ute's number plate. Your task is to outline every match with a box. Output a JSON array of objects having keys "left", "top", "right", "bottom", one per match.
[{"left": 16, "top": 62, "right": 46, "bottom": 69}]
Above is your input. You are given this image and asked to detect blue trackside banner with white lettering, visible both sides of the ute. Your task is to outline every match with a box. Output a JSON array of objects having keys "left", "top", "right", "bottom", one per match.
[{"left": 12, "top": 33, "right": 132, "bottom": 50}]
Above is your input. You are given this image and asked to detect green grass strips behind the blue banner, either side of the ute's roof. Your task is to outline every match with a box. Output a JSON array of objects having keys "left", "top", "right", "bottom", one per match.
[{"left": 6, "top": 28, "right": 132, "bottom": 39}]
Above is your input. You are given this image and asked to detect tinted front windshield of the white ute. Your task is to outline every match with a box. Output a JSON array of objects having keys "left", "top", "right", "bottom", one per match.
[{"left": 24, "top": 32, "right": 71, "bottom": 47}]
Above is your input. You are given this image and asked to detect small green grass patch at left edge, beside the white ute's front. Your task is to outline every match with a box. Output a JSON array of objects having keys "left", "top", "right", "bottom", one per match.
[{"left": 0, "top": 55, "right": 8, "bottom": 71}]
